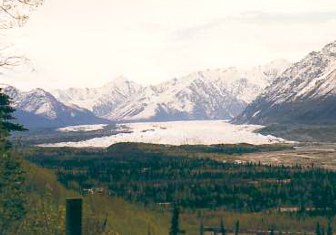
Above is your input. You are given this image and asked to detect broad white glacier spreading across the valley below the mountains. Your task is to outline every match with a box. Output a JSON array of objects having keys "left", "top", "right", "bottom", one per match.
[{"left": 39, "top": 120, "right": 288, "bottom": 148}]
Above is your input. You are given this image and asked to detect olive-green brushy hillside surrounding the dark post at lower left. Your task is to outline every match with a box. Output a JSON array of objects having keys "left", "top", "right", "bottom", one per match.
[{"left": 19, "top": 159, "right": 169, "bottom": 235}]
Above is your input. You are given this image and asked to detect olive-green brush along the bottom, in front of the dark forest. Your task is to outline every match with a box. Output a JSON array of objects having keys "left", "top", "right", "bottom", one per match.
[{"left": 3, "top": 159, "right": 336, "bottom": 235}]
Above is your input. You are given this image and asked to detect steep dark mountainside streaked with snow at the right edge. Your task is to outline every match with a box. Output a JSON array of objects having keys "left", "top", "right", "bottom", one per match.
[{"left": 236, "top": 41, "right": 336, "bottom": 124}]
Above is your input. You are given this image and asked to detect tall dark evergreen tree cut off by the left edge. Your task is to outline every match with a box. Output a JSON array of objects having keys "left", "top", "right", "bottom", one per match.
[{"left": 0, "top": 89, "right": 25, "bottom": 235}]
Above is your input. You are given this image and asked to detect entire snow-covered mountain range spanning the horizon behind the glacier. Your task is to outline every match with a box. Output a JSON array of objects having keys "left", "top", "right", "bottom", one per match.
[{"left": 2, "top": 42, "right": 336, "bottom": 128}]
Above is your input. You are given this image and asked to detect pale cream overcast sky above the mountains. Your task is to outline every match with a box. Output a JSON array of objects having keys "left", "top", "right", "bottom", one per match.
[{"left": 0, "top": 0, "right": 336, "bottom": 90}]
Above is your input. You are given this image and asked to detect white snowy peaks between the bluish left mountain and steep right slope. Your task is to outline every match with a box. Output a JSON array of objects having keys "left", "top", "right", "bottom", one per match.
[{"left": 52, "top": 60, "right": 289, "bottom": 121}]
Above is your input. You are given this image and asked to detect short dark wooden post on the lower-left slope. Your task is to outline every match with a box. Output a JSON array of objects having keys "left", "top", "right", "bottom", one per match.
[{"left": 66, "top": 198, "right": 82, "bottom": 235}]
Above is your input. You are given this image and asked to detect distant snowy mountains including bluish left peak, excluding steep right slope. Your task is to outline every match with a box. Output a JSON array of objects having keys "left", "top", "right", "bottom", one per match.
[{"left": 0, "top": 60, "right": 289, "bottom": 127}]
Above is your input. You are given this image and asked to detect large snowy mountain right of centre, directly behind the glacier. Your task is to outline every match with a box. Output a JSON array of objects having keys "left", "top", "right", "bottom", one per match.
[{"left": 104, "top": 60, "right": 288, "bottom": 121}]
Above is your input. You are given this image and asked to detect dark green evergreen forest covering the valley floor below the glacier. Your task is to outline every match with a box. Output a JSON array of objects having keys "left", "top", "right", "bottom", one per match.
[{"left": 29, "top": 145, "right": 336, "bottom": 215}]
